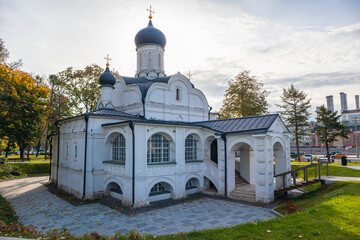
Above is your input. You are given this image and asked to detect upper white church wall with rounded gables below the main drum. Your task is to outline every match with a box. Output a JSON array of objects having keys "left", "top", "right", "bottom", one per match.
[{"left": 112, "top": 74, "right": 209, "bottom": 122}]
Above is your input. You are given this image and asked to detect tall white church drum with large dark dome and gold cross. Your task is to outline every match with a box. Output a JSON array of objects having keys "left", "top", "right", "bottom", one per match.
[{"left": 135, "top": 7, "right": 166, "bottom": 80}]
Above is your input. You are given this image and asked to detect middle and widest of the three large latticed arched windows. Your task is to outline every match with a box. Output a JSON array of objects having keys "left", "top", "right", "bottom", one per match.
[{"left": 147, "top": 133, "right": 170, "bottom": 163}]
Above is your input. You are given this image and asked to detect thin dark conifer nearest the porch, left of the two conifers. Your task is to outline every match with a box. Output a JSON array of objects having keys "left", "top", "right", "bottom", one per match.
[{"left": 277, "top": 84, "right": 311, "bottom": 160}]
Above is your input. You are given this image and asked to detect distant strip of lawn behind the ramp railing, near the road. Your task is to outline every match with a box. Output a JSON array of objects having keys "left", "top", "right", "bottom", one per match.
[{"left": 291, "top": 165, "right": 360, "bottom": 179}]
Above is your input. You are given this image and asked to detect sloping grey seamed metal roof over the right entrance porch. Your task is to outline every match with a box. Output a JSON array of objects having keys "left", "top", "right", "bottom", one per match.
[{"left": 194, "top": 114, "right": 279, "bottom": 133}]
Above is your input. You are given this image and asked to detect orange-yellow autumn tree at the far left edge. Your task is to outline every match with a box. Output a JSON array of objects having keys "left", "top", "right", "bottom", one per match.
[{"left": 0, "top": 64, "right": 49, "bottom": 158}]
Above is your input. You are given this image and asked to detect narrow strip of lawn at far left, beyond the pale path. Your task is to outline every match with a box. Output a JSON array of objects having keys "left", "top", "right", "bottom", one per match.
[{"left": 0, "top": 163, "right": 50, "bottom": 180}]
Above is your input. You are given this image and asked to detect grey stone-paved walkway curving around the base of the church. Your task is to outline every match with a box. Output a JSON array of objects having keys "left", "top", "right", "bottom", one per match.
[{"left": 0, "top": 177, "right": 275, "bottom": 235}]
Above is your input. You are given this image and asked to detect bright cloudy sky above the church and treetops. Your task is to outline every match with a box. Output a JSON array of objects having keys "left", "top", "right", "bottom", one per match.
[{"left": 0, "top": 0, "right": 360, "bottom": 118}]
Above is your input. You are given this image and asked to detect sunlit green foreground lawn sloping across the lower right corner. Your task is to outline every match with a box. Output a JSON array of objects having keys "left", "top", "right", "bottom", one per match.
[{"left": 157, "top": 182, "right": 360, "bottom": 240}]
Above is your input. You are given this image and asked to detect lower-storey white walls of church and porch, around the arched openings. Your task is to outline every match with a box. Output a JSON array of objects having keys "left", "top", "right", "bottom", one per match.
[{"left": 52, "top": 116, "right": 291, "bottom": 206}]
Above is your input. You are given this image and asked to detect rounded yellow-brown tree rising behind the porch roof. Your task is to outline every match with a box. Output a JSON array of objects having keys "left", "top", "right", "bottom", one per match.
[{"left": 220, "top": 71, "right": 270, "bottom": 118}]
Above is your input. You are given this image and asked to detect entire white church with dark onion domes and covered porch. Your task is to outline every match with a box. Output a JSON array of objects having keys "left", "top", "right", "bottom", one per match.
[{"left": 51, "top": 15, "right": 290, "bottom": 207}]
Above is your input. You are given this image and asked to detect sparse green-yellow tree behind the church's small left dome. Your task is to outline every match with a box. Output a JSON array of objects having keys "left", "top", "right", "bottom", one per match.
[{"left": 54, "top": 64, "right": 104, "bottom": 114}]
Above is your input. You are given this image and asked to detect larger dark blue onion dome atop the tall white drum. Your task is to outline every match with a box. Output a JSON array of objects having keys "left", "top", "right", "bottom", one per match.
[{"left": 135, "top": 20, "right": 166, "bottom": 48}]
